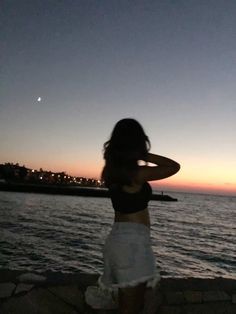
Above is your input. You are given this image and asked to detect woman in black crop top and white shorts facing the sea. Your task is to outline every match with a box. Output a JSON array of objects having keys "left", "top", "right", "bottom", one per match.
[{"left": 99, "top": 118, "right": 180, "bottom": 314}]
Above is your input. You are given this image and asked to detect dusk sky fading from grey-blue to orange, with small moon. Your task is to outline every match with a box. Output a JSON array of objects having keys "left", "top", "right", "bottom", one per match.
[{"left": 0, "top": 0, "right": 236, "bottom": 195}]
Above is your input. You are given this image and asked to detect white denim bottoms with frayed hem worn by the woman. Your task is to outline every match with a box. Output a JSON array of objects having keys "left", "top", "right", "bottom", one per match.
[{"left": 98, "top": 222, "right": 160, "bottom": 290}]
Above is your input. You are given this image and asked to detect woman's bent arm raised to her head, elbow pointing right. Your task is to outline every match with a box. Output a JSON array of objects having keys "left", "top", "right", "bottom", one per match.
[{"left": 136, "top": 153, "right": 180, "bottom": 183}]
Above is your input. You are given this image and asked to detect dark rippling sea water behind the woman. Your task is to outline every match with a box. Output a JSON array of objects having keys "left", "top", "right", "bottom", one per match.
[{"left": 0, "top": 192, "right": 236, "bottom": 279}]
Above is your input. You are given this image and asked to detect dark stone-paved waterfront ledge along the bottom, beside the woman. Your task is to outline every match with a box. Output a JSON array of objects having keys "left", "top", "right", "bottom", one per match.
[{"left": 0, "top": 269, "right": 236, "bottom": 314}]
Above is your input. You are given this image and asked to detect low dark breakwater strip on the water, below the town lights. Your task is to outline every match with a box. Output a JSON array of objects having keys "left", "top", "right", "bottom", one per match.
[{"left": 0, "top": 183, "right": 177, "bottom": 202}]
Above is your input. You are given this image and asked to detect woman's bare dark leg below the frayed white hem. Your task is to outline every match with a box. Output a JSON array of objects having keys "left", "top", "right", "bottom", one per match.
[{"left": 119, "top": 283, "right": 146, "bottom": 314}]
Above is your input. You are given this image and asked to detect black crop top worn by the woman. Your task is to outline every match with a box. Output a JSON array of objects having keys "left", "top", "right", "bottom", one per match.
[{"left": 109, "top": 182, "right": 152, "bottom": 214}]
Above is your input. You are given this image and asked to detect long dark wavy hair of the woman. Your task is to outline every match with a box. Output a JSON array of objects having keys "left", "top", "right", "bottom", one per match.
[{"left": 102, "top": 118, "right": 151, "bottom": 187}]
